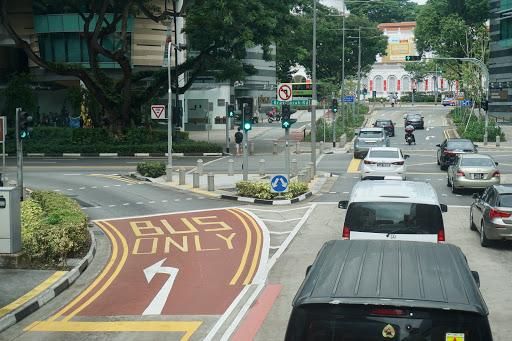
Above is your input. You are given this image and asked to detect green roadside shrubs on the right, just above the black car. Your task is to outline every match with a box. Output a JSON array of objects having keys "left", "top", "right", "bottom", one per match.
[{"left": 450, "top": 108, "right": 505, "bottom": 142}]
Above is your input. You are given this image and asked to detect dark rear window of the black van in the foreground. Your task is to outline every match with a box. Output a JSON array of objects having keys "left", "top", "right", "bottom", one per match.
[{"left": 286, "top": 304, "right": 492, "bottom": 341}]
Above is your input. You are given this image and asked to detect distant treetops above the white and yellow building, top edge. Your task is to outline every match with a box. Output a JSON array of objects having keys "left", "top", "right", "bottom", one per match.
[{"left": 346, "top": 0, "right": 420, "bottom": 24}]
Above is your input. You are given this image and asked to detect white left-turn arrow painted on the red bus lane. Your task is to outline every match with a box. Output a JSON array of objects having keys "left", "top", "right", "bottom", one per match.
[{"left": 142, "top": 258, "right": 179, "bottom": 315}]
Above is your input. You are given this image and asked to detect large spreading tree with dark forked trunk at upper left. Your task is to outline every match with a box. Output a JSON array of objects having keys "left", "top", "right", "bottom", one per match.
[{"left": 0, "top": 0, "right": 295, "bottom": 134}]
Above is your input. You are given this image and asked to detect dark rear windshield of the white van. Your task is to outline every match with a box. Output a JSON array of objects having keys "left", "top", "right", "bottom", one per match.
[{"left": 344, "top": 202, "right": 443, "bottom": 234}]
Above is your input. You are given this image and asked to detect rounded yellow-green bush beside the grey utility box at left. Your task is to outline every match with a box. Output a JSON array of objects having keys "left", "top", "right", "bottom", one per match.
[{"left": 21, "top": 191, "right": 89, "bottom": 265}]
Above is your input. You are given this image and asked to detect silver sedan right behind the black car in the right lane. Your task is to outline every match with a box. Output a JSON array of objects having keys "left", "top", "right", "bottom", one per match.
[{"left": 447, "top": 154, "right": 500, "bottom": 193}]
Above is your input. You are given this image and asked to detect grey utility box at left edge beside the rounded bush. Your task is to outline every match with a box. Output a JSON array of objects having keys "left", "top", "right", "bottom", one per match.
[{"left": 0, "top": 187, "right": 21, "bottom": 253}]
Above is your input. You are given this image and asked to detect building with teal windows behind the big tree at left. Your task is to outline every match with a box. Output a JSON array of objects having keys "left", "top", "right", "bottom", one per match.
[{"left": 0, "top": 0, "right": 276, "bottom": 130}]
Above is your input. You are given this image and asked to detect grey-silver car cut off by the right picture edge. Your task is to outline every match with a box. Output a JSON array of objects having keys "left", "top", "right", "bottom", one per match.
[{"left": 469, "top": 185, "right": 512, "bottom": 247}]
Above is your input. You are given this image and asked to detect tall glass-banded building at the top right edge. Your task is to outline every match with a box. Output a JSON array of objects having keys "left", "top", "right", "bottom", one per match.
[{"left": 489, "top": 0, "right": 512, "bottom": 120}]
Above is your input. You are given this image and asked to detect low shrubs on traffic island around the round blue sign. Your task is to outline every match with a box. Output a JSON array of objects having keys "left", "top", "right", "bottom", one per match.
[{"left": 236, "top": 181, "right": 309, "bottom": 200}]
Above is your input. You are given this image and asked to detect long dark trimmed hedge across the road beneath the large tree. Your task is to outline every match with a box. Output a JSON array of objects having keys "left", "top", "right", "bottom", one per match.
[{"left": 6, "top": 127, "right": 222, "bottom": 155}]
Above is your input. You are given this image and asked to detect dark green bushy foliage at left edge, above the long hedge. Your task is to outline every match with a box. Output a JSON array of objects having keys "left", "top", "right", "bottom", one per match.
[{"left": 0, "top": 73, "right": 37, "bottom": 126}]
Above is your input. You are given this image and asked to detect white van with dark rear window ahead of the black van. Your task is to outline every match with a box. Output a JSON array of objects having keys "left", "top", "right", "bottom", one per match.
[{"left": 338, "top": 180, "right": 447, "bottom": 243}]
